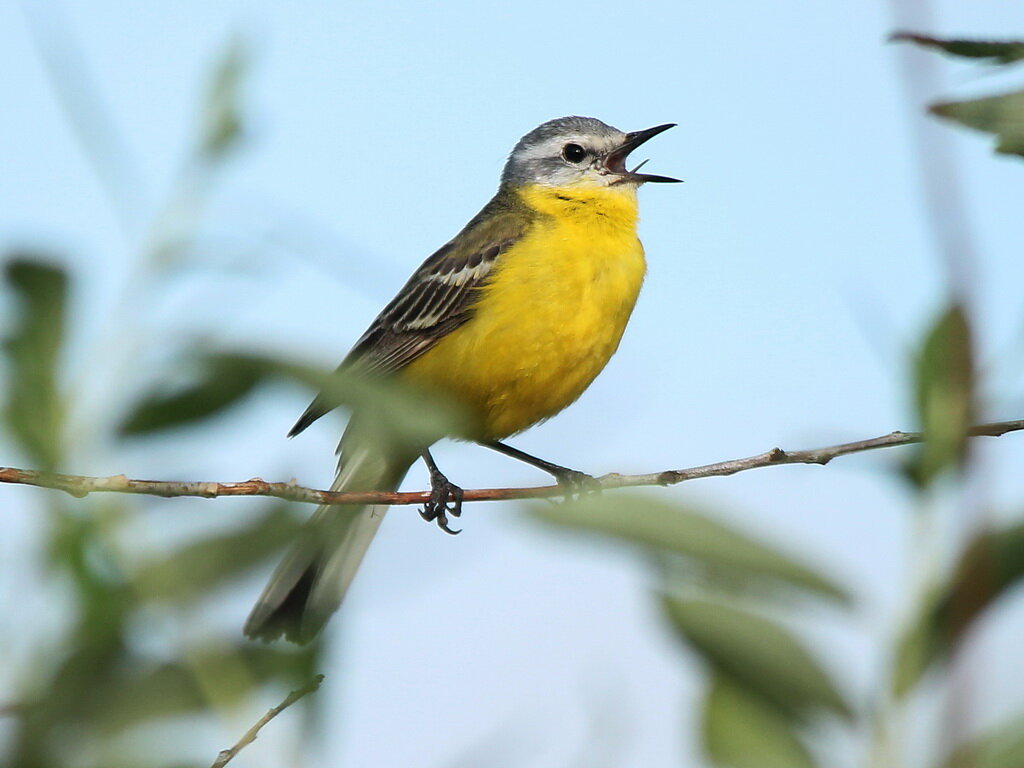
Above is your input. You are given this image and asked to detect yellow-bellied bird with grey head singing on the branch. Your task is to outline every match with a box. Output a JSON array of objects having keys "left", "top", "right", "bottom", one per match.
[{"left": 244, "top": 116, "right": 679, "bottom": 644}]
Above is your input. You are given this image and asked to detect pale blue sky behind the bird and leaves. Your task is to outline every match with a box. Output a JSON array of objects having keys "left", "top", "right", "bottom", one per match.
[{"left": 0, "top": 0, "right": 1024, "bottom": 767}]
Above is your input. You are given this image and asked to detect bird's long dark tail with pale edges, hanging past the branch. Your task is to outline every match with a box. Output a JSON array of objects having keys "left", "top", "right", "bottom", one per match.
[{"left": 245, "top": 446, "right": 412, "bottom": 643}]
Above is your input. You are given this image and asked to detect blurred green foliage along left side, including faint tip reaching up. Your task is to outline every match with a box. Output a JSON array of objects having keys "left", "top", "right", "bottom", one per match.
[{"left": 0, "top": 34, "right": 321, "bottom": 768}]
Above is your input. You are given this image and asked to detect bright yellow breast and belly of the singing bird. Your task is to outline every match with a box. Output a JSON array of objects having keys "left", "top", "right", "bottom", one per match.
[{"left": 403, "top": 182, "right": 645, "bottom": 439}]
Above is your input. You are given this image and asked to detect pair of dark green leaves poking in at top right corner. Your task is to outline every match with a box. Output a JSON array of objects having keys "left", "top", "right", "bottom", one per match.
[{"left": 893, "top": 33, "right": 1024, "bottom": 157}]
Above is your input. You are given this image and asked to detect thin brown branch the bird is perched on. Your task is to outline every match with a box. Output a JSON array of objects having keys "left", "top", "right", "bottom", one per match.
[{"left": 0, "top": 419, "right": 1024, "bottom": 506}]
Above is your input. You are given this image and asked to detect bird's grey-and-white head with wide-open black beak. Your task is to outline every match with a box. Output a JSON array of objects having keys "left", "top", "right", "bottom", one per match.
[{"left": 502, "top": 117, "right": 679, "bottom": 189}]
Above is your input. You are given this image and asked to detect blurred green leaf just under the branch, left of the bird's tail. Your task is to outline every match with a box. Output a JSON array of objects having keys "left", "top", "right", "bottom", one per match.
[{"left": 134, "top": 504, "right": 301, "bottom": 604}]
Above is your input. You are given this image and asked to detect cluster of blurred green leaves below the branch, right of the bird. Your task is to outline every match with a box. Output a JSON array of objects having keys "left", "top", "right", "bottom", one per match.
[{"left": 532, "top": 493, "right": 858, "bottom": 768}]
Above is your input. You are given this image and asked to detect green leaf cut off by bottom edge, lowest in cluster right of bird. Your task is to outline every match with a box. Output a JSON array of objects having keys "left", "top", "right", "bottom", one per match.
[{"left": 702, "top": 674, "right": 815, "bottom": 768}]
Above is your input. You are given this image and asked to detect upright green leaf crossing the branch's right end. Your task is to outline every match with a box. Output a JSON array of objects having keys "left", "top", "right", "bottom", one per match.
[{"left": 910, "top": 303, "right": 975, "bottom": 486}]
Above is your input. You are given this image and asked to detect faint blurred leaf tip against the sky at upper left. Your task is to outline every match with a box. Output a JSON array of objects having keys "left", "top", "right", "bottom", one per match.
[{"left": 199, "top": 40, "right": 249, "bottom": 158}]
